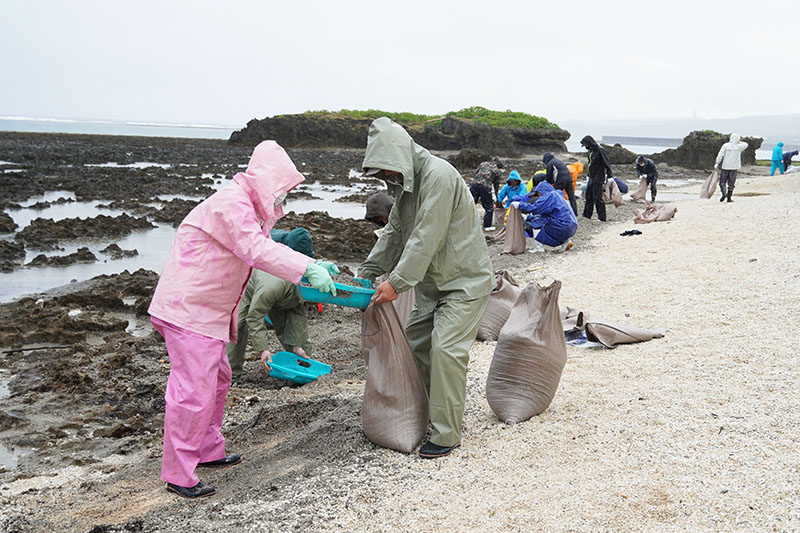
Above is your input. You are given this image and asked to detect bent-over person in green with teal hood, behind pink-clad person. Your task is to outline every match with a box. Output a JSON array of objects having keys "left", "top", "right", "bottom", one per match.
[{"left": 228, "top": 228, "right": 314, "bottom": 384}]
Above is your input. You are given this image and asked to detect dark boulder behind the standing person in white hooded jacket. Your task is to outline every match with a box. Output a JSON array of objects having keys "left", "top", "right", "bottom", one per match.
[{"left": 651, "top": 130, "right": 764, "bottom": 169}]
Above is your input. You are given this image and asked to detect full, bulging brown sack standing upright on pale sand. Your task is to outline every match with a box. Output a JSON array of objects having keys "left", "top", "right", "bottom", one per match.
[{"left": 486, "top": 281, "right": 567, "bottom": 424}]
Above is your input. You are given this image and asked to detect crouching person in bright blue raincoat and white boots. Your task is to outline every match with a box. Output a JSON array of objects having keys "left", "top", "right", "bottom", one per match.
[{"left": 511, "top": 181, "right": 578, "bottom": 252}]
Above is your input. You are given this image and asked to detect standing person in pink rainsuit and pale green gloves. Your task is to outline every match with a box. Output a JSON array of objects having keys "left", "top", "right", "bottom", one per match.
[{"left": 149, "top": 141, "right": 339, "bottom": 498}]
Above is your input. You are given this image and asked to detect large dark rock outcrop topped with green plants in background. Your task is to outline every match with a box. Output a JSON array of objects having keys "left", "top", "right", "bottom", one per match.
[{"left": 228, "top": 115, "right": 570, "bottom": 153}]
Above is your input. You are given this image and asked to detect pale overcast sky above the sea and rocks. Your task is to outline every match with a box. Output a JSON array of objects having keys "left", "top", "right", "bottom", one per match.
[{"left": 0, "top": 0, "right": 800, "bottom": 126}]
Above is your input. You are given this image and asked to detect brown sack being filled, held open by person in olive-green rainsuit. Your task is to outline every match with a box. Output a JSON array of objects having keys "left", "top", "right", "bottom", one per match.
[{"left": 361, "top": 302, "right": 428, "bottom": 453}]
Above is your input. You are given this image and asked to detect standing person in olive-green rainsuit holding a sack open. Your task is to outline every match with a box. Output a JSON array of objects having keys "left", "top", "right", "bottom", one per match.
[{"left": 359, "top": 117, "right": 494, "bottom": 458}]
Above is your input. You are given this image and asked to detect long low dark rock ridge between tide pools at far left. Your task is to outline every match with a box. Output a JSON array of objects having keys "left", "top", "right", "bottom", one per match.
[{"left": 14, "top": 213, "right": 155, "bottom": 247}]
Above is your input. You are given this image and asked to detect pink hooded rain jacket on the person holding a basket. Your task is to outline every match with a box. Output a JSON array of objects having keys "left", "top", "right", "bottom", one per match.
[{"left": 148, "top": 141, "right": 314, "bottom": 342}]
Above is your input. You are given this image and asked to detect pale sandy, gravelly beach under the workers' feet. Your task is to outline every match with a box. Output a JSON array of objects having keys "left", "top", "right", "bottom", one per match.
[{"left": 0, "top": 138, "right": 800, "bottom": 532}]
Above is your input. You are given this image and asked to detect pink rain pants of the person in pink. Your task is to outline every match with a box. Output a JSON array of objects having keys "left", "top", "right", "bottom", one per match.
[{"left": 150, "top": 317, "right": 231, "bottom": 487}]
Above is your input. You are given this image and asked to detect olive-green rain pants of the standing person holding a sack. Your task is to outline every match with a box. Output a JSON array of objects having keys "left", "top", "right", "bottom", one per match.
[{"left": 406, "top": 295, "right": 489, "bottom": 446}]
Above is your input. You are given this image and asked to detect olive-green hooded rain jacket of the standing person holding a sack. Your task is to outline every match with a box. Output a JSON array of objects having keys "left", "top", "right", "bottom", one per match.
[{"left": 359, "top": 117, "right": 494, "bottom": 310}]
